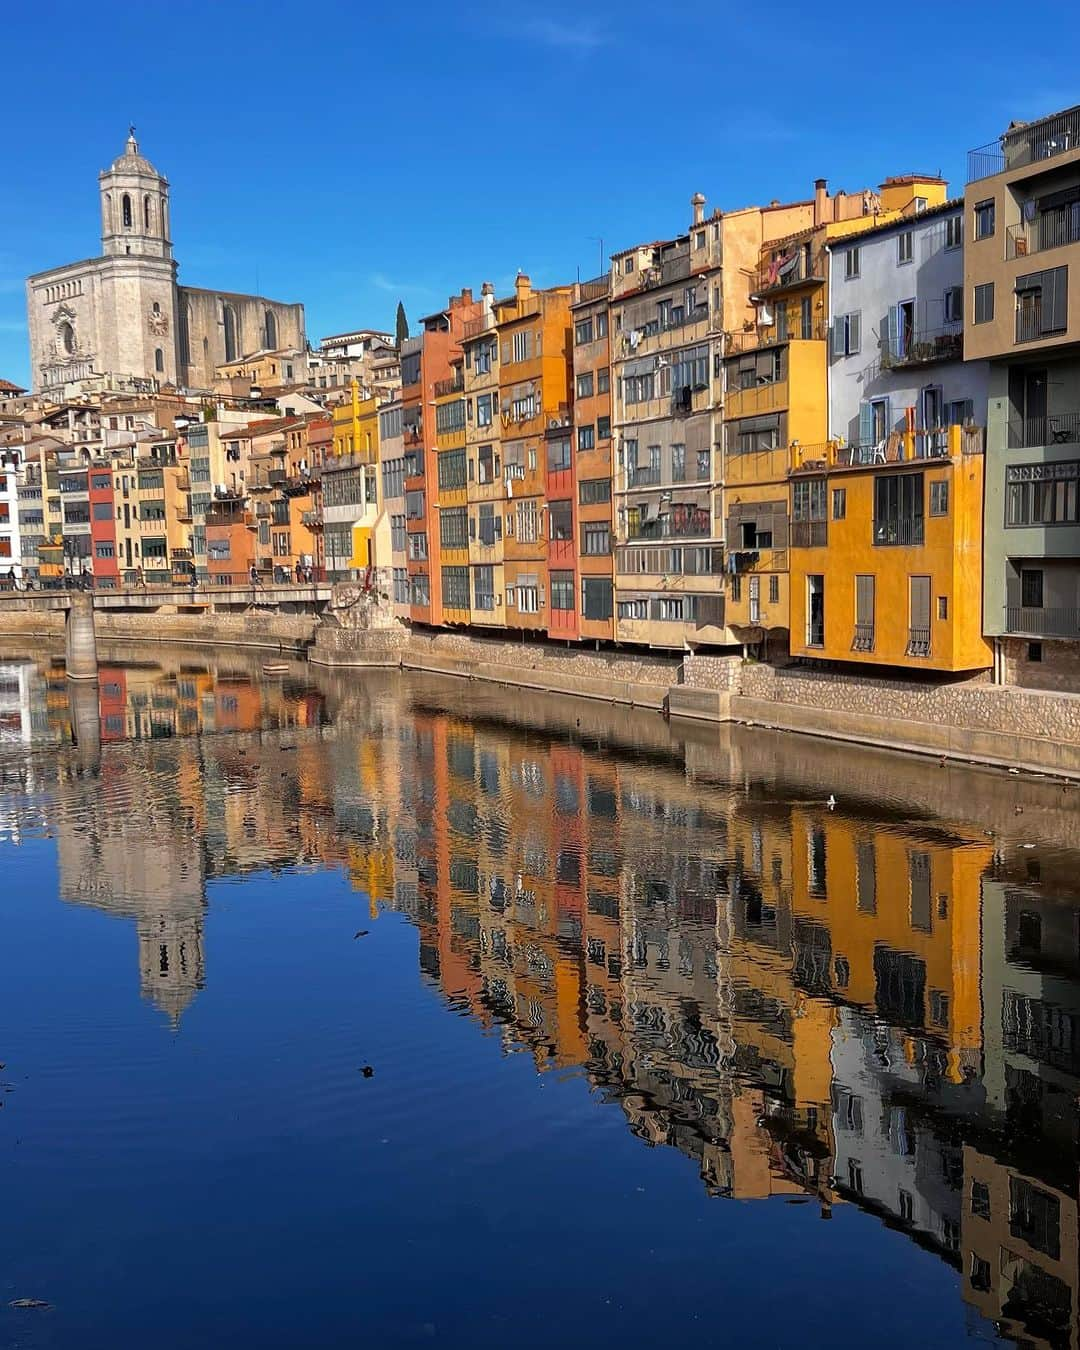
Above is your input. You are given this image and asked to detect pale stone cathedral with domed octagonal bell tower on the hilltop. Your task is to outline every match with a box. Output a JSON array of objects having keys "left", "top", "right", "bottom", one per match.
[{"left": 26, "top": 127, "right": 306, "bottom": 394}]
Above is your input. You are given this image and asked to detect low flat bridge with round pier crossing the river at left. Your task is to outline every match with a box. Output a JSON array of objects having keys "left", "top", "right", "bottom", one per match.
[{"left": 0, "top": 582, "right": 333, "bottom": 679}]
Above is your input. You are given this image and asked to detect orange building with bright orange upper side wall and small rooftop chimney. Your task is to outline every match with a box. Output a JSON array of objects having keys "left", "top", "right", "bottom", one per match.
[{"left": 495, "top": 273, "right": 576, "bottom": 637}]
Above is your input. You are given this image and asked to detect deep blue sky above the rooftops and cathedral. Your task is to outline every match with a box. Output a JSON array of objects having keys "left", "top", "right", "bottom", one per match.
[{"left": 0, "top": 0, "right": 1080, "bottom": 383}]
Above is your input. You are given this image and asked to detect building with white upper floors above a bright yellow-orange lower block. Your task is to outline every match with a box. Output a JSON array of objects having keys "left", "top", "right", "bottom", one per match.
[{"left": 790, "top": 187, "right": 992, "bottom": 671}]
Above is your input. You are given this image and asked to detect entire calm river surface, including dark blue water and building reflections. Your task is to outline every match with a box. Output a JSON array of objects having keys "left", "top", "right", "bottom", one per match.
[{"left": 0, "top": 648, "right": 1080, "bottom": 1350}]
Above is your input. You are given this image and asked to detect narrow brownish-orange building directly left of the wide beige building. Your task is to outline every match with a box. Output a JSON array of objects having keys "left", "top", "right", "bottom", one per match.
[{"left": 571, "top": 277, "right": 614, "bottom": 640}]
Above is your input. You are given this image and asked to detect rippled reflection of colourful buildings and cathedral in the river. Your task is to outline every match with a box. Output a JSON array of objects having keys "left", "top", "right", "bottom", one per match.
[{"left": 0, "top": 655, "right": 1080, "bottom": 1346}]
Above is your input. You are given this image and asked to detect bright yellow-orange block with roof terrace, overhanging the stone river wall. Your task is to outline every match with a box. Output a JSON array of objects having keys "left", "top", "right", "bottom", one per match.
[{"left": 790, "top": 427, "right": 991, "bottom": 671}]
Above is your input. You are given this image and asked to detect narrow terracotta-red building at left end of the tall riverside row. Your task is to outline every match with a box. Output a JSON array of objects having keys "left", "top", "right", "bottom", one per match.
[{"left": 401, "top": 288, "right": 481, "bottom": 626}]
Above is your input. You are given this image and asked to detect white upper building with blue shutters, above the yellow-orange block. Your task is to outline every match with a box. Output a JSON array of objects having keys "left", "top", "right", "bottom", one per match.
[{"left": 829, "top": 201, "right": 988, "bottom": 459}]
